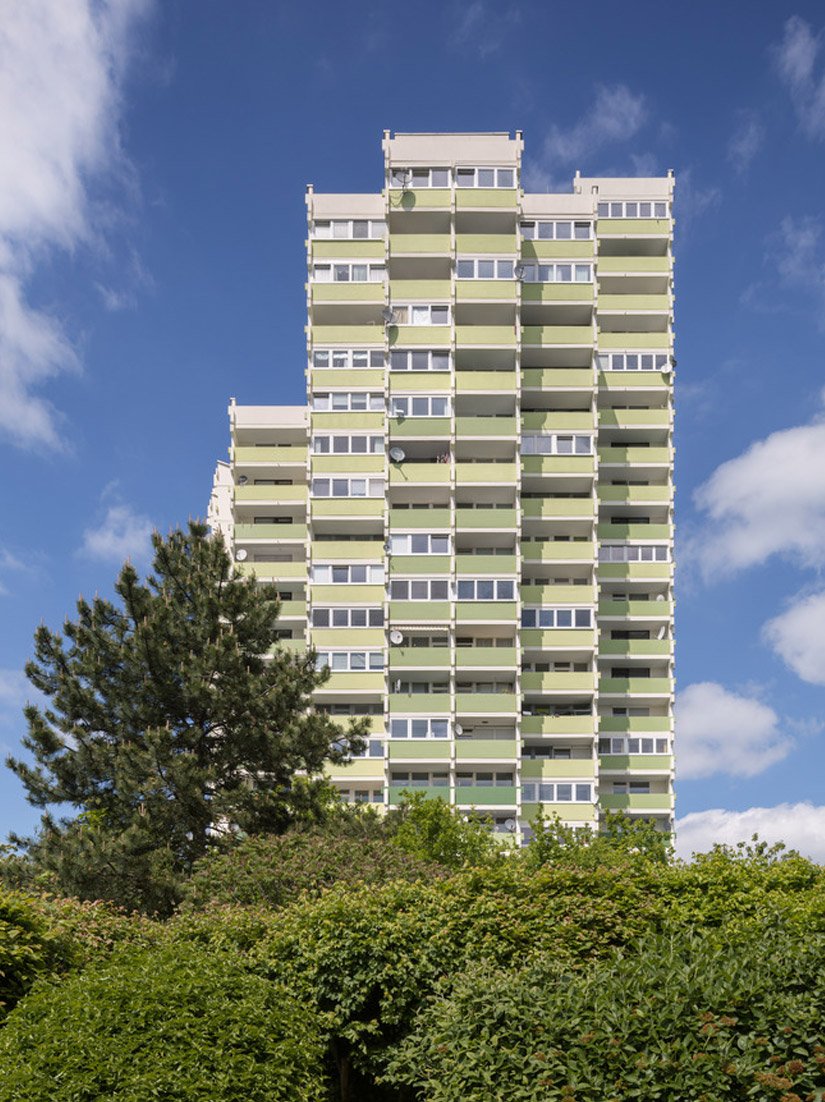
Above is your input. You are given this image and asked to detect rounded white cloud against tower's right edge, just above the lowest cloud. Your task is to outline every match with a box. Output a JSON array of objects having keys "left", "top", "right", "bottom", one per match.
[{"left": 675, "top": 681, "right": 793, "bottom": 780}]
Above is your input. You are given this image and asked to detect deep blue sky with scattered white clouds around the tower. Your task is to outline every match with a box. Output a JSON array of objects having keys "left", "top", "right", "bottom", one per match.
[{"left": 0, "top": 0, "right": 825, "bottom": 861}]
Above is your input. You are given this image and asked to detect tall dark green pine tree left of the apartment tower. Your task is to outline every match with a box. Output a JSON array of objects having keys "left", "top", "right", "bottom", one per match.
[{"left": 7, "top": 522, "right": 363, "bottom": 912}]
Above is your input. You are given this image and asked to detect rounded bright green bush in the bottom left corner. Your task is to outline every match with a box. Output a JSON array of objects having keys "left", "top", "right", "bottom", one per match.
[{"left": 0, "top": 946, "right": 325, "bottom": 1102}]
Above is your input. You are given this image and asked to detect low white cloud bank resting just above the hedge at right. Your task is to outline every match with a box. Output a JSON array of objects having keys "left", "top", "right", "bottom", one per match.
[{"left": 676, "top": 803, "right": 825, "bottom": 864}]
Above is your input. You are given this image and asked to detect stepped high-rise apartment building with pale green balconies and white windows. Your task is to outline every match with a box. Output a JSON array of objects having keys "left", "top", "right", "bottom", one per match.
[{"left": 211, "top": 132, "right": 674, "bottom": 836}]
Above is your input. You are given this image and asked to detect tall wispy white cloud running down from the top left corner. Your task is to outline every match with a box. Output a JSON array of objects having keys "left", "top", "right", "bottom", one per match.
[{"left": 0, "top": 0, "right": 151, "bottom": 447}]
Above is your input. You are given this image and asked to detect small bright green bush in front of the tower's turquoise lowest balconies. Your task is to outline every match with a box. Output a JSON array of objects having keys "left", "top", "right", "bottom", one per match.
[{"left": 390, "top": 792, "right": 500, "bottom": 868}]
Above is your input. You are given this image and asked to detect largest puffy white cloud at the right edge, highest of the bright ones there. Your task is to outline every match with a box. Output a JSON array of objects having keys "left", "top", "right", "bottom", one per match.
[{"left": 688, "top": 394, "right": 825, "bottom": 580}]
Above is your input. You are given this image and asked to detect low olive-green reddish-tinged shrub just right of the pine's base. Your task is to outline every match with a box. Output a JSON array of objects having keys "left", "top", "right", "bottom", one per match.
[{"left": 184, "top": 817, "right": 444, "bottom": 909}]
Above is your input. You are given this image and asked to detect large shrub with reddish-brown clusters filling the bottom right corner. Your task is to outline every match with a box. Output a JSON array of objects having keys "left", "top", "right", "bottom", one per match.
[{"left": 389, "top": 927, "right": 825, "bottom": 1102}]
